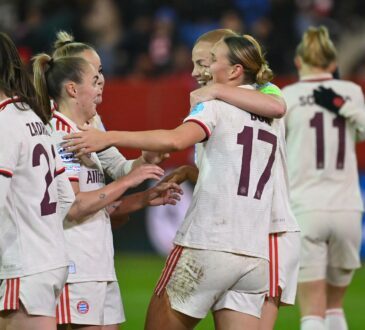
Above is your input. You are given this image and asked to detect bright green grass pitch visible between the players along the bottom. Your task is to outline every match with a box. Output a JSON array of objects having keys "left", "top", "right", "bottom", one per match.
[{"left": 115, "top": 254, "right": 365, "bottom": 330}]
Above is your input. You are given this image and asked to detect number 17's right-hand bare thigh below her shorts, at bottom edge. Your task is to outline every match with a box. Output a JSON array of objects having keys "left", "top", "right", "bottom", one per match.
[{"left": 213, "top": 309, "right": 260, "bottom": 330}]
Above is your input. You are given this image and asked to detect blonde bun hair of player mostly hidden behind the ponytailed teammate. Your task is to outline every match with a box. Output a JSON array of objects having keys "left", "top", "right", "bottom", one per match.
[{"left": 52, "top": 31, "right": 94, "bottom": 59}]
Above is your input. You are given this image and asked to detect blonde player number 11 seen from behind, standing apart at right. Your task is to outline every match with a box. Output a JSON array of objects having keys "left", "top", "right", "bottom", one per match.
[{"left": 283, "top": 26, "right": 364, "bottom": 330}]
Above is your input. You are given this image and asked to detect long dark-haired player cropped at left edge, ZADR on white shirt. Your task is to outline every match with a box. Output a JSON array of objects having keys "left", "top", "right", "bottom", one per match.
[{"left": 0, "top": 33, "right": 74, "bottom": 330}]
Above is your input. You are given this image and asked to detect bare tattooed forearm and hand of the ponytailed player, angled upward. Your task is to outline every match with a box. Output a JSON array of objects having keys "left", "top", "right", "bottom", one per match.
[{"left": 67, "top": 165, "right": 164, "bottom": 221}]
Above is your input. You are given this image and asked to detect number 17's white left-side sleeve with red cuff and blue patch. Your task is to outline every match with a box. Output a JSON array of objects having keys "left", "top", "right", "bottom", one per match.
[{"left": 184, "top": 100, "right": 221, "bottom": 140}]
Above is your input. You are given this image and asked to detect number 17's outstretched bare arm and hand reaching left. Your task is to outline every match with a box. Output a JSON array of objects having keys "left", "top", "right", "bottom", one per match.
[{"left": 64, "top": 122, "right": 206, "bottom": 154}]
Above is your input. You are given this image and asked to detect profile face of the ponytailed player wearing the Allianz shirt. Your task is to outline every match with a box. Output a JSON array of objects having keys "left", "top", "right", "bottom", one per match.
[{"left": 75, "top": 63, "right": 101, "bottom": 122}]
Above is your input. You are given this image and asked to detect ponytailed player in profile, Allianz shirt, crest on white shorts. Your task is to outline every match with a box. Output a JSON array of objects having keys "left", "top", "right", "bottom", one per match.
[{"left": 34, "top": 54, "right": 182, "bottom": 330}]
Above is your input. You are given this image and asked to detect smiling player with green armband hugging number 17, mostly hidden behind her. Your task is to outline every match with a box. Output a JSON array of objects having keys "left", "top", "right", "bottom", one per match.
[{"left": 164, "top": 29, "right": 300, "bottom": 330}]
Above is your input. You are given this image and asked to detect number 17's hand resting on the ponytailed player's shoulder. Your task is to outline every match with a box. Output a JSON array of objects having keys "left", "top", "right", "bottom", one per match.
[{"left": 63, "top": 125, "right": 109, "bottom": 157}]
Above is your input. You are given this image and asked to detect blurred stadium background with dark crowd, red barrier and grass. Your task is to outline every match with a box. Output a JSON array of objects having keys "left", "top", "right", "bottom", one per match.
[{"left": 0, "top": 0, "right": 365, "bottom": 329}]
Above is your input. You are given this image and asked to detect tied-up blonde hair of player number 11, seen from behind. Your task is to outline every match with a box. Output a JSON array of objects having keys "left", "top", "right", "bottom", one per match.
[{"left": 296, "top": 26, "right": 337, "bottom": 69}]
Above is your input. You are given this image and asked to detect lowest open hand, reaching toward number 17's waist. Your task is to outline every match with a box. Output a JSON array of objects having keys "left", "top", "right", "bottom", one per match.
[{"left": 144, "top": 182, "right": 184, "bottom": 206}]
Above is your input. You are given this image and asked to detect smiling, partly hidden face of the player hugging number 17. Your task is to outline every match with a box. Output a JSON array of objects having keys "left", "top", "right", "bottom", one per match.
[{"left": 191, "top": 41, "right": 214, "bottom": 86}]
